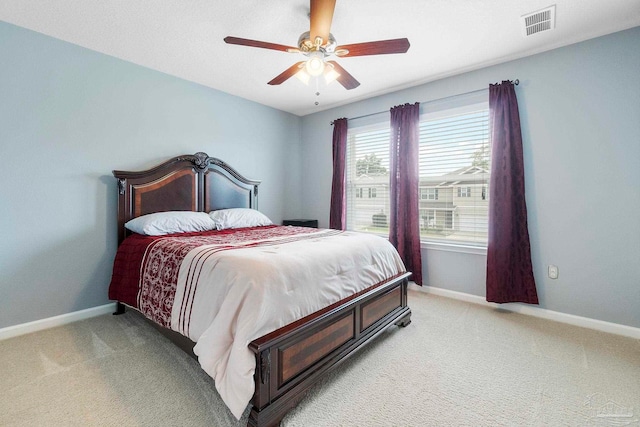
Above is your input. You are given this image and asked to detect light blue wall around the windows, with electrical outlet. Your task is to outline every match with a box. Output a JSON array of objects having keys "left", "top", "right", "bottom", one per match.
[{"left": 302, "top": 28, "right": 640, "bottom": 327}]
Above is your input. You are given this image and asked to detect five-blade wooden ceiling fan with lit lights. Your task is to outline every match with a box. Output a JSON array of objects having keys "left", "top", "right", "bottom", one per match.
[{"left": 224, "top": 0, "right": 409, "bottom": 90}]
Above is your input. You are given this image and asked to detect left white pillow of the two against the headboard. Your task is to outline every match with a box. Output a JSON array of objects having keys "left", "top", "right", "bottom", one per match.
[{"left": 124, "top": 211, "right": 216, "bottom": 236}]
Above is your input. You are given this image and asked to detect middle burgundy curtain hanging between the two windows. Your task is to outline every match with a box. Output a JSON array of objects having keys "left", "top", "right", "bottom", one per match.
[{"left": 389, "top": 102, "right": 422, "bottom": 285}]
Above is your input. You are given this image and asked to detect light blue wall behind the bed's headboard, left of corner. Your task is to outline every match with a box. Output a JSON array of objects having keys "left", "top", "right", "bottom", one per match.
[{"left": 0, "top": 22, "right": 301, "bottom": 328}]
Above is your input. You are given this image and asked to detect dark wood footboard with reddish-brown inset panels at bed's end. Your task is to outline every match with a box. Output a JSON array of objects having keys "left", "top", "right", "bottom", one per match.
[{"left": 248, "top": 273, "right": 411, "bottom": 427}]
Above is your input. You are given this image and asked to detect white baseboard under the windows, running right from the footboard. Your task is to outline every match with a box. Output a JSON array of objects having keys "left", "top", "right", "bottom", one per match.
[{"left": 409, "top": 284, "right": 640, "bottom": 339}]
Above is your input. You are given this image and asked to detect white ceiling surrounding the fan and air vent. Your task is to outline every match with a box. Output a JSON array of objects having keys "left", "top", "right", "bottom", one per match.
[{"left": 0, "top": 0, "right": 640, "bottom": 116}]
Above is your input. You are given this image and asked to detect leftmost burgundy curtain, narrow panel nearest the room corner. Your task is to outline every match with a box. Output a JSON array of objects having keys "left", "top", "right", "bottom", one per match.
[{"left": 329, "top": 118, "right": 347, "bottom": 230}]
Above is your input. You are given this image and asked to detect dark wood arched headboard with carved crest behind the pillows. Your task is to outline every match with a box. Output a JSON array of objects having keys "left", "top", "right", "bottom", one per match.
[{"left": 113, "top": 152, "right": 260, "bottom": 244}]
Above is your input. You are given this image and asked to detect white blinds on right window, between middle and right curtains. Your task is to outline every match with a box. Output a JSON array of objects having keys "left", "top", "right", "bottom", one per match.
[{"left": 420, "top": 105, "right": 491, "bottom": 245}]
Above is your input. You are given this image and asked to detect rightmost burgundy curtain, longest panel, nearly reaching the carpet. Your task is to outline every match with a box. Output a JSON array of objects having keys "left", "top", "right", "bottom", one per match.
[{"left": 487, "top": 81, "right": 538, "bottom": 304}]
